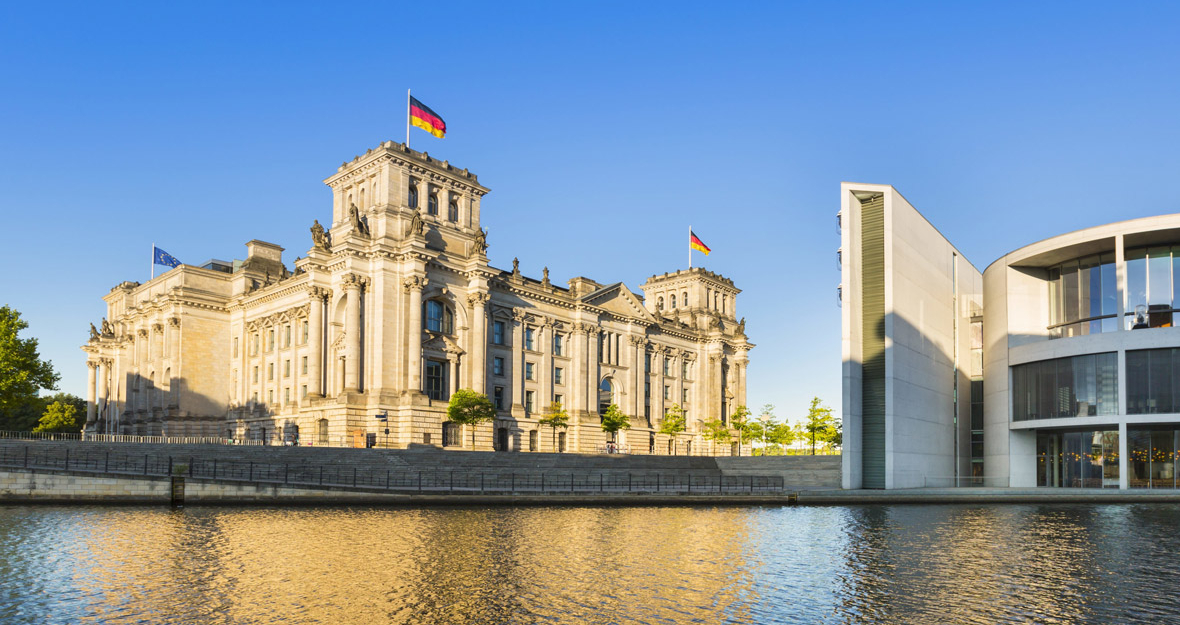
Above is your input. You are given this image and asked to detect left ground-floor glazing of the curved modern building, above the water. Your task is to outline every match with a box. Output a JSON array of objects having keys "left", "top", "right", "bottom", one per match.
[{"left": 1036, "top": 429, "right": 1119, "bottom": 488}]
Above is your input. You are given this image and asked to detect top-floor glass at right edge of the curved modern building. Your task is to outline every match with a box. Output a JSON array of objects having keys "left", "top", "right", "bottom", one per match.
[{"left": 1126, "top": 245, "right": 1180, "bottom": 330}]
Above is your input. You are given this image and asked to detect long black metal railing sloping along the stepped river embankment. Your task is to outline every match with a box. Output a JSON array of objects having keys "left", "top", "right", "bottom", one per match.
[{"left": 0, "top": 445, "right": 785, "bottom": 495}]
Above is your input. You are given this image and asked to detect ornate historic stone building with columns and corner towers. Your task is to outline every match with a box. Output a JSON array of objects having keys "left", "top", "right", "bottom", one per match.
[{"left": 83, "top": 142, "right": 753, "bottom": 454}]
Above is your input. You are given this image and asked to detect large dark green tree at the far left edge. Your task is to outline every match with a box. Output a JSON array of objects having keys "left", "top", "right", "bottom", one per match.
[{"left": 0, "top": 305, "right": 60, "bottom": 421}]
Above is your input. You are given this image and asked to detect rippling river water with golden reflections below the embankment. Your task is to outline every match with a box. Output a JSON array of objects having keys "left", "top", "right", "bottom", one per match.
[{"left": 0, "top": 505, "right": 1180, "bottom": 624}]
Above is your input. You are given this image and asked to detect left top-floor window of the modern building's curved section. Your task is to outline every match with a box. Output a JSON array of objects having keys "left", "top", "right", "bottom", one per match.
[{"left": 1049, "top": 254, "right": 1113, "bottom": 338}]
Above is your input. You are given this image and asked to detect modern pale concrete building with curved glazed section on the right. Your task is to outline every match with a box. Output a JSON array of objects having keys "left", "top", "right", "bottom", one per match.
[{"left": 840, "top": 184, "right": 1180, "bottom": 488}]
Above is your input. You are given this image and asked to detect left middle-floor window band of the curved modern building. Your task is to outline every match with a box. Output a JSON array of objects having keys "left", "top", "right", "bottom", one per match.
[{"left": 1012, "top": 351, "right": 1119, "bottom": 421}]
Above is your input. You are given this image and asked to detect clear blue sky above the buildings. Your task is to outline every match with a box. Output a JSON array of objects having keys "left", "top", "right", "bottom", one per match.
[{"left": 0, "top": 2, "right": 1180, "bottom": 419}]
